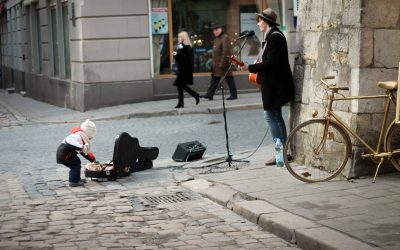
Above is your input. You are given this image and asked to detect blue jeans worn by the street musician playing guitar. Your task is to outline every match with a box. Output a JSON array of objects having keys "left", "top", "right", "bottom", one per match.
[{"left": 264, "top": 108, "right": 287, "bottom": 144}]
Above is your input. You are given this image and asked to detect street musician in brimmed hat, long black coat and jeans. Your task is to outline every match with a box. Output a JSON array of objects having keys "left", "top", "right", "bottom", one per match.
[{"left": 242, "top": 8, "right": 294, "bottom": 165}]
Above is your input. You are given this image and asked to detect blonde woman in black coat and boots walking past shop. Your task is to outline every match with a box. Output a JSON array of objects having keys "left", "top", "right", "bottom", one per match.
[{"left": 173, "top": 31, "right": 200, "bottom": 108}]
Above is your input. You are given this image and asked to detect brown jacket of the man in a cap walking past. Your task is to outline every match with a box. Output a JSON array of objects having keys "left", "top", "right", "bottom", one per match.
[{"left": 212, "top": 33, "right": 232, "bottom": 77}]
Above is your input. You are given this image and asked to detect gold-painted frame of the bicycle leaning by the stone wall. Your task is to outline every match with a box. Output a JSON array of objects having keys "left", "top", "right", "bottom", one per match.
[{"left": 317, "top": 89, "right": 395, "bottom": 158}]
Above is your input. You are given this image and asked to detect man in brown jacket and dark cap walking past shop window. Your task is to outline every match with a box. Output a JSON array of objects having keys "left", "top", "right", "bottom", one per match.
[{"left": 203, "top": 22, "right": 237, "bottom": 101}]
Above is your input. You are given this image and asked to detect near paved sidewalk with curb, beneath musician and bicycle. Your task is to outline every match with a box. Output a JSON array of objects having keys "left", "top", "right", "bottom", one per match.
[{"left": 175, "top": 145, "right": 400, "bottom": 250}]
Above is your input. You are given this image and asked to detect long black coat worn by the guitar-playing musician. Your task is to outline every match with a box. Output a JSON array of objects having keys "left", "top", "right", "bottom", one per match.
[{"left": 249, "top": 27, "right": 294, "bottom": 110}]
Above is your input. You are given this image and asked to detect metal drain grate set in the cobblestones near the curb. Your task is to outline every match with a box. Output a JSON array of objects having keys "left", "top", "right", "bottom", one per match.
[{"left": 128, "top": 192, "right": 193, "bottom": 209}]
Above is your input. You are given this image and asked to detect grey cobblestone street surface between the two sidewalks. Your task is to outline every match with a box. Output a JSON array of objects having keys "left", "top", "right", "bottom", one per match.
[{"left": 0, "top": 95, "right": 295, "bottom": 249}]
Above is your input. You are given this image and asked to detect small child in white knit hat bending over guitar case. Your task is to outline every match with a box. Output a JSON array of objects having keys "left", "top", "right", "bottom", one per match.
[{"left": 57, "top": 119, "right": 96, "bottom": 187}]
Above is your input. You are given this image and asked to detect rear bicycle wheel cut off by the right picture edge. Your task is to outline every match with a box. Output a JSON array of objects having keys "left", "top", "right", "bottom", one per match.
[{"left": 385, "top": 121, "right": 400, "bottom": 171}]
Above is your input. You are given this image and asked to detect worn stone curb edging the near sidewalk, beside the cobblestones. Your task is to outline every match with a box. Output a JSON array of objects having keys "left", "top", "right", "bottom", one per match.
[{"left": 178, "top": 176, "right": 380, "bottom": 250}]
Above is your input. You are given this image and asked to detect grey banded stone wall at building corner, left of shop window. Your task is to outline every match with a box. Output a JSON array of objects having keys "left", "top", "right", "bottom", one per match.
[{"left": 70, "top": 0, "right": 153, "bottom": 110}]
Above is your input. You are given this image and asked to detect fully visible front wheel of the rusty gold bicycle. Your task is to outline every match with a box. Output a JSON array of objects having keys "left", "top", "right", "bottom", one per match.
[{"left": 284, "top": 119, "right": 351, "bottom": 182}]
